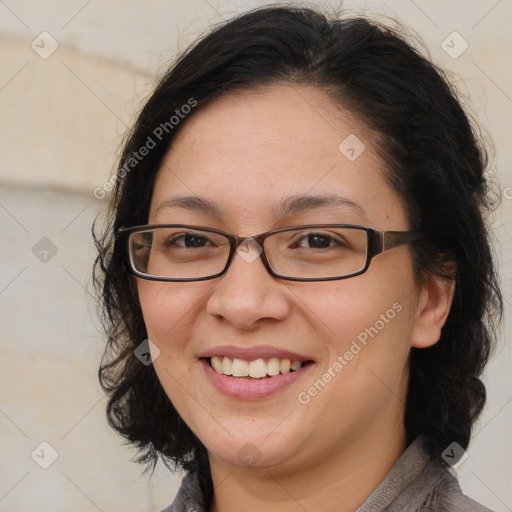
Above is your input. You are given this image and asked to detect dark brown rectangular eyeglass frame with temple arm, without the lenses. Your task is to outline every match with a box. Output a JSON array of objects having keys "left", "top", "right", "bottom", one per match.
[{"left": 114, "top": 224, "right": 426, "bottom": 282}]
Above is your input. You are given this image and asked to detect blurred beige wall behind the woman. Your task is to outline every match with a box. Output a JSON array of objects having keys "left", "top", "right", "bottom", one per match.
[{"left": 0, "top": 0, "right": 512, "bottom": 512}]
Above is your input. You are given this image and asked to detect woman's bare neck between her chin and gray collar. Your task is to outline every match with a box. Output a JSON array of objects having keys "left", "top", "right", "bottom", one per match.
[{"left": 210, "top": 422, "right": 406, "bottom": 512}]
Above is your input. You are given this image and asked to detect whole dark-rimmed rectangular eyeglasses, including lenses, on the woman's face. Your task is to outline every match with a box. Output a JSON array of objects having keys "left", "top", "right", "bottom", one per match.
[{"left": 115, "top": 224, "right": 424, "bottom": 281}]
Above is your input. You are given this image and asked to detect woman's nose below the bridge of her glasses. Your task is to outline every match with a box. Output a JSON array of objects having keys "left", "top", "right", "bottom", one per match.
[{"left": 206, "top": 239, "right": 290, "bottom": 330}]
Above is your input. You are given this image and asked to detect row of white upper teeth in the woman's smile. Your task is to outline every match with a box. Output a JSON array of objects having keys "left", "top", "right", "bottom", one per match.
[{"left": 211, "top": 356, "right": 302, "bottom": 379}]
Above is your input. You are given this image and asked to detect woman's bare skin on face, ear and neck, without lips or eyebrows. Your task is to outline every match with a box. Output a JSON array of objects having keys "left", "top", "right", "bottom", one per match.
[{"left": 137, "top": 85, "right": 453, "bottom": 512}]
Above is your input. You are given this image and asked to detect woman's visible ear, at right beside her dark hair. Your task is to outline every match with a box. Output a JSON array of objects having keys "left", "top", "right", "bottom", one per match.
[{"left": 411, "top": 276, "right": 455, "bottom": 348}]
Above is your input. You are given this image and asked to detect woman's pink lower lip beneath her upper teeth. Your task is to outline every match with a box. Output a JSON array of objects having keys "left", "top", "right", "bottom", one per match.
[{"left": 200, "top": 359, "right": 313, "bottom": 400}]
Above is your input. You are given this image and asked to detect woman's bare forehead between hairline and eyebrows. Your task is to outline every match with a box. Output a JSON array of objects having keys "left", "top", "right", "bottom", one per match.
[{"left": 150, "top": 85, "right": 403, "bottom": 229}]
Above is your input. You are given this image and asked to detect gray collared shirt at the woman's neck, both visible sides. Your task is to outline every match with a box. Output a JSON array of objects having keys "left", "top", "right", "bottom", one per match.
[{"left": 162, "top": 439, "right": 492, "bottom": 512}]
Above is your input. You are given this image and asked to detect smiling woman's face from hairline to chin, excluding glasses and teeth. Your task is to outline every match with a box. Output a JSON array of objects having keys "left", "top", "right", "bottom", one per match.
[{"left": 137, "top": 85, "right": 424, "bottom": 470}]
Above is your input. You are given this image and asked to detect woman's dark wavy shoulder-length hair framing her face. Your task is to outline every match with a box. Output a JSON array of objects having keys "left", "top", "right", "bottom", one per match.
[{"left": 93, "top": 7, "right": 503, "bottom": 504}]
